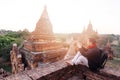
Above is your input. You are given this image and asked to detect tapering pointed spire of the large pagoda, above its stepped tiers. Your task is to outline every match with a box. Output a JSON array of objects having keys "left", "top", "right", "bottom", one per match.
[{"left": 30, "top": 6, "right": 54, "bottom": 40}]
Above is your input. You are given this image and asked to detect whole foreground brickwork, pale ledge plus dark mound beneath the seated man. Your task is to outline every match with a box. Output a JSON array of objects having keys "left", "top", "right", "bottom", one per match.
[{"left": 5, "top": 60, "right": 120, "bottom": 80}]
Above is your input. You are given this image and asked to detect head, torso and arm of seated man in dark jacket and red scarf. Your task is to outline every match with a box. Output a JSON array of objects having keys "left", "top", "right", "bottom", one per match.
[{"left": 79, "top": 38, "right": 101, "bottom": 71}]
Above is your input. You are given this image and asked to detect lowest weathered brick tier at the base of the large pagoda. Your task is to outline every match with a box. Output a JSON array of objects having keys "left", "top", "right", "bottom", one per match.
[{"left": 20, "top": 48, "right": 67, "bottom": 68}]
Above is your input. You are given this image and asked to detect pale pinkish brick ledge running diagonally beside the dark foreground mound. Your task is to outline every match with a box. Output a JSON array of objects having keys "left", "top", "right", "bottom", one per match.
[{"left": 5, "top": 60, "right": 67, "bottom": 80}]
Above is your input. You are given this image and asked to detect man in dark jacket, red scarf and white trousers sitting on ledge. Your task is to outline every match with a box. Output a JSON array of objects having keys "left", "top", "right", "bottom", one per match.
[{"left": 67, "top": 38, "right": 107, "bottom": 71}]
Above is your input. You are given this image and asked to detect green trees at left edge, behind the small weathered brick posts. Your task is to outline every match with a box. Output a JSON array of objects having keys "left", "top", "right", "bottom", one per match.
[{"left": 0, "top": 31, "right": 29, "bottom": 61}]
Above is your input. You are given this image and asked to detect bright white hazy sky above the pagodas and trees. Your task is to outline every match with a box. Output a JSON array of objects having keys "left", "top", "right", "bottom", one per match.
[{"left": 0, "top": 0, "right": 120, "bottom": 34}]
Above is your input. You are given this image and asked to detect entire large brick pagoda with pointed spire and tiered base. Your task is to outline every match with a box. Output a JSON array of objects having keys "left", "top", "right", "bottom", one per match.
[{"left": 20, "top": 7, "right": 67, "bottom": 68}]
